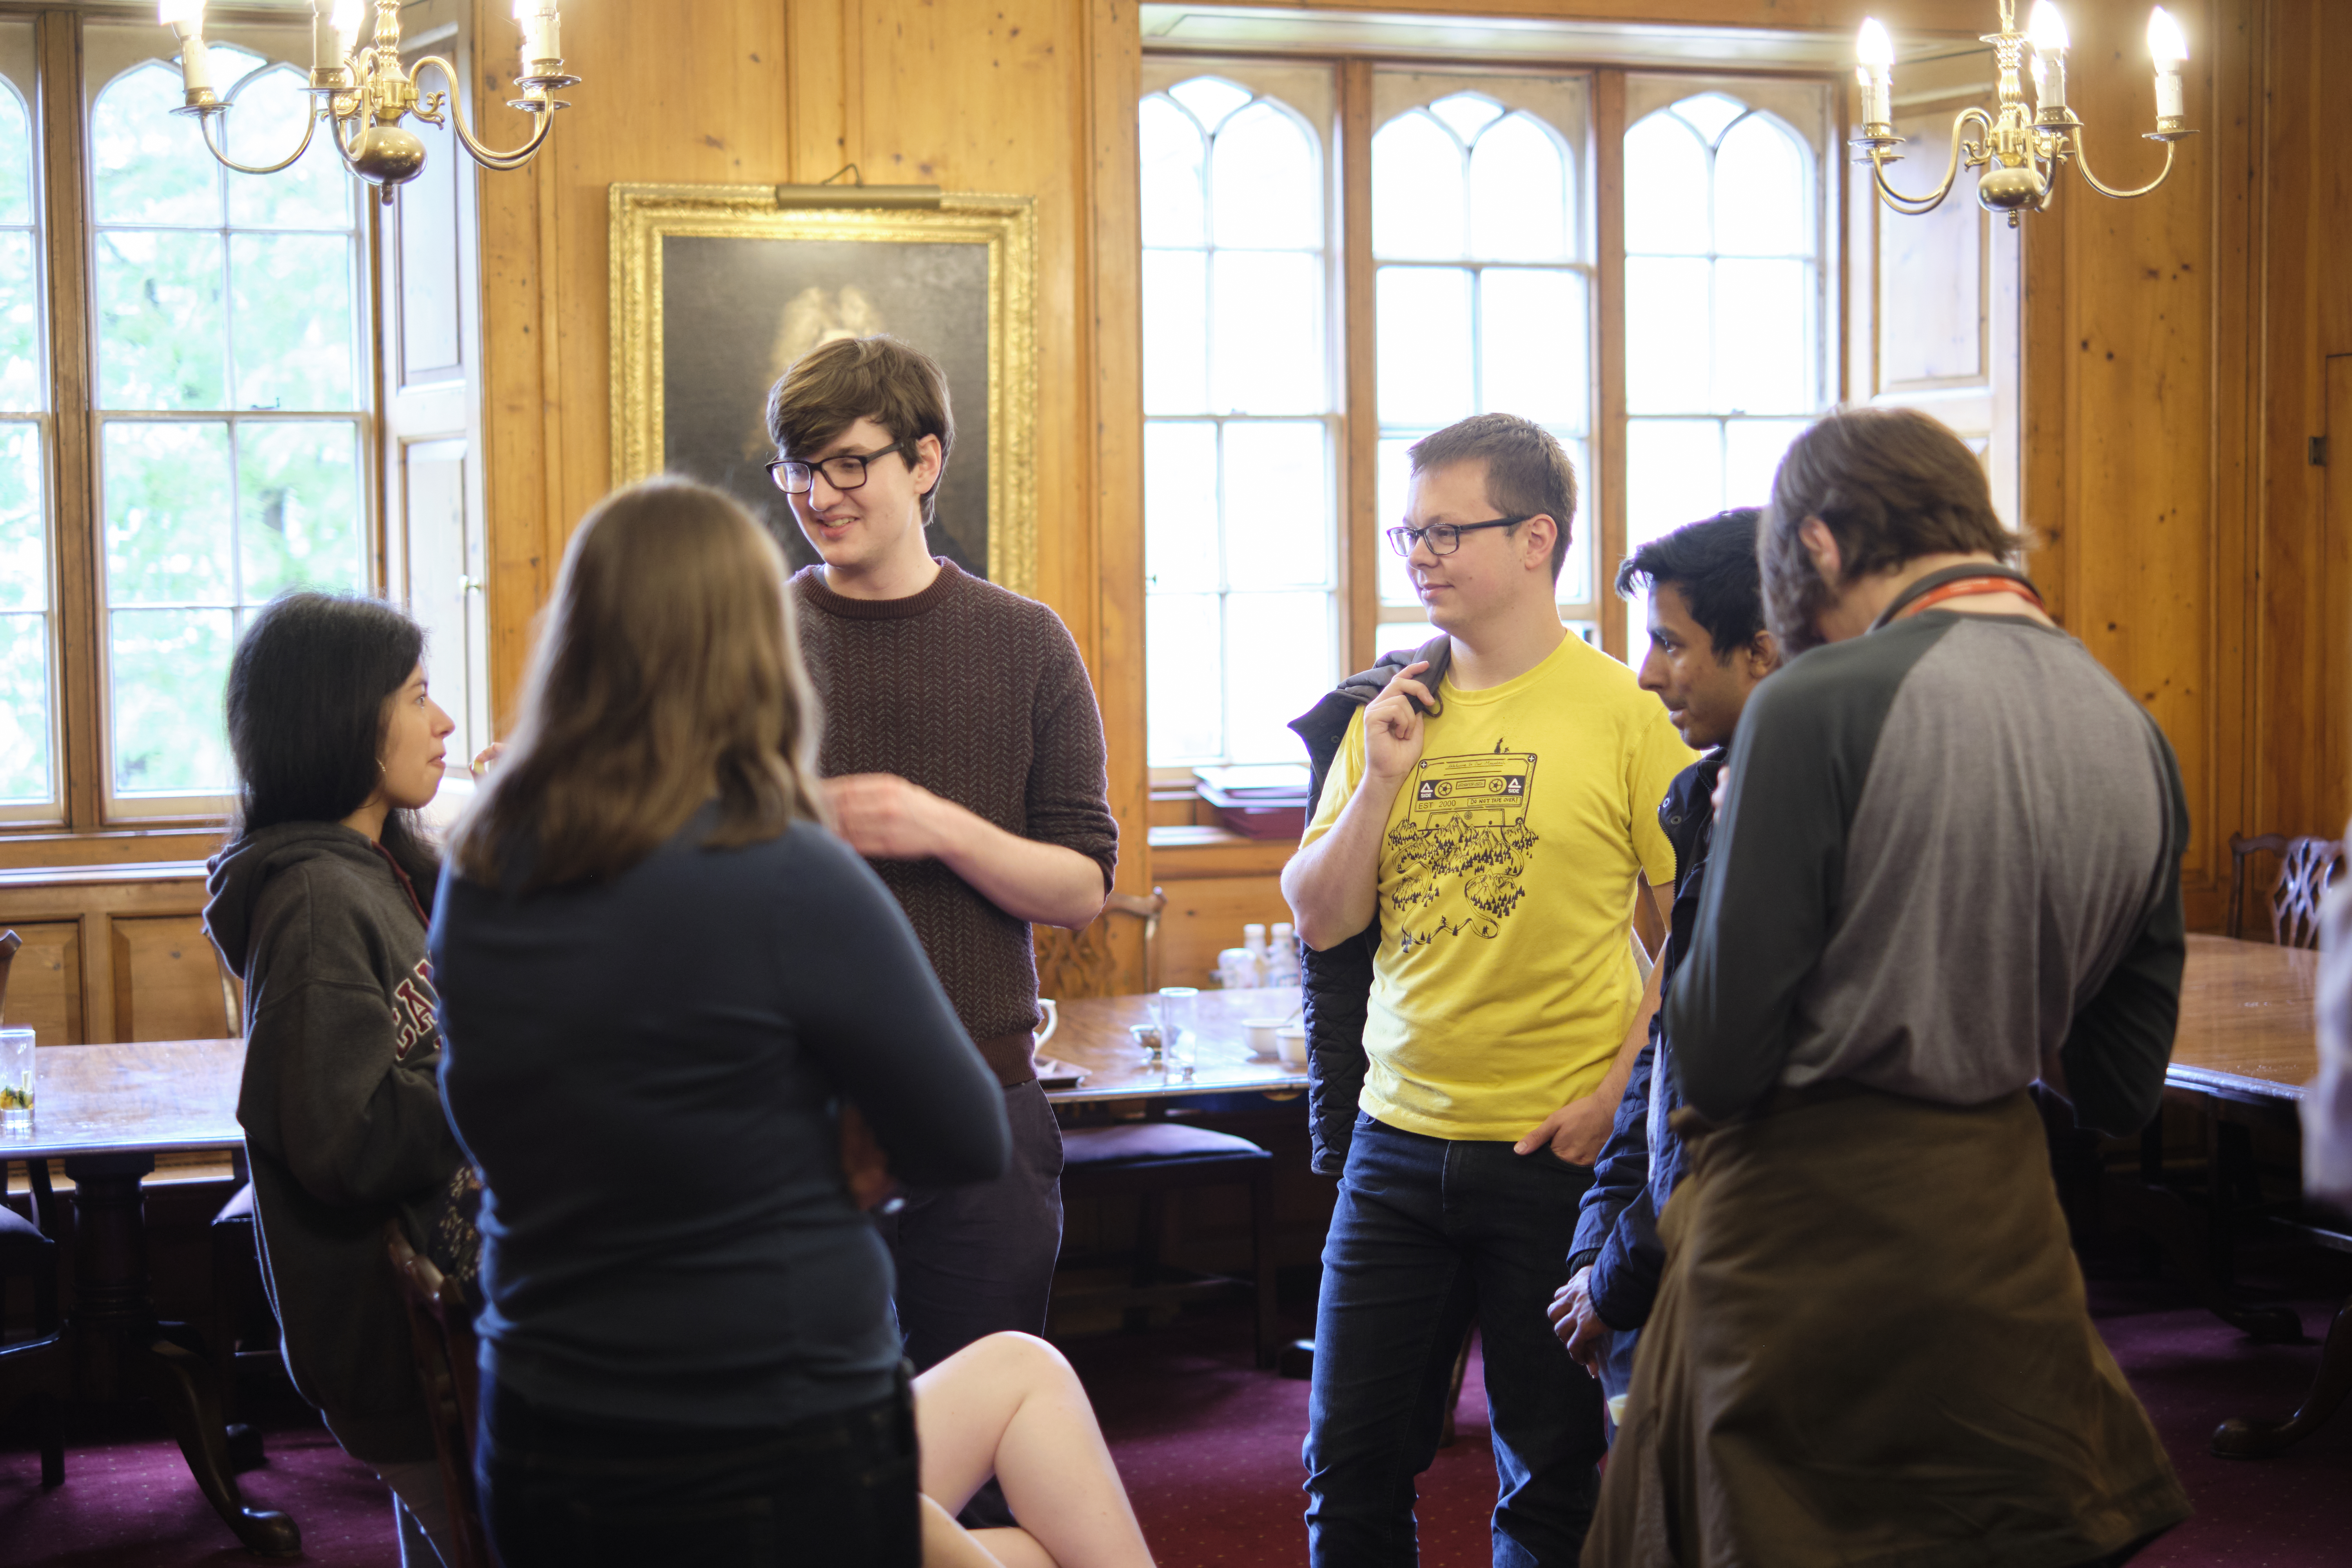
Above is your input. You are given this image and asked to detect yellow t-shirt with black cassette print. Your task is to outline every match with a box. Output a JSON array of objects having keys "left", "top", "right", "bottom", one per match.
[{"left": 1305, "top": 637, "right": 1696, "bottom": 1140}]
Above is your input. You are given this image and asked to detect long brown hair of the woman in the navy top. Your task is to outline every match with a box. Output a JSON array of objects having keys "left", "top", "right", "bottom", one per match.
[{"left": 449, "top": 477, "right": 823, "bottom": 889}]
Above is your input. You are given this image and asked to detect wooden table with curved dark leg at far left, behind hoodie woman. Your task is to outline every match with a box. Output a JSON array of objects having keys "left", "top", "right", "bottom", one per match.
[{"left": 0, "top": 1039, "right": 301, "bottom": 1559}]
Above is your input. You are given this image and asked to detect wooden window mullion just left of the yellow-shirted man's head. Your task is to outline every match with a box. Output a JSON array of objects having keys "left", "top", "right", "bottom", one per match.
[{"left": 1336, "top": 61, "right": 1397, "bottom": 670}]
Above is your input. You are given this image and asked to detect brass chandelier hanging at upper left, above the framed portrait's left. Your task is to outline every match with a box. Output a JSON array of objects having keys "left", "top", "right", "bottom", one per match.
[{"left": 155, "top": 0, "right": 579, "bottom": 202}]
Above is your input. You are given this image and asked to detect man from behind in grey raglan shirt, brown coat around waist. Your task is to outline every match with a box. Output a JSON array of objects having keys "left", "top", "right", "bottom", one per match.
[{"left": 1585, "top": 409, "right": 2190, "bottom": 1568}]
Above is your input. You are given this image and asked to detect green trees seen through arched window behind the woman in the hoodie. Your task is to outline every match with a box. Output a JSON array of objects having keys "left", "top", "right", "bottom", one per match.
[{"left": 89, "top": 45, "right": 367, "bottom": 795}]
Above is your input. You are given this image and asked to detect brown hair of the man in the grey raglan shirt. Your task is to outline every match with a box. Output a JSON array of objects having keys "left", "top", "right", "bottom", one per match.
[{"left": 1757, "top": 409, "right": 2025, "bottom": 653}]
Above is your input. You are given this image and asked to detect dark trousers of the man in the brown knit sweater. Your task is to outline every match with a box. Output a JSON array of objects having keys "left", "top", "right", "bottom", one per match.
[{"left": 880, "top": 1079, "right": 1061, "bottom": 1373}]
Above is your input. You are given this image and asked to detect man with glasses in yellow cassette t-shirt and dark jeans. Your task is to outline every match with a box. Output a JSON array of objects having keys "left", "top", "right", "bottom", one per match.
[{"left": 1282, "top": 414, "right": 1693, "bottom": 1568}]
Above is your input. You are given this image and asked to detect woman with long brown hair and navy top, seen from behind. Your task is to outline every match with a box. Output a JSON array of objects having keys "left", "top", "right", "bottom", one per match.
[{"left": 433, "top": 479, "right": 1007, "bottom": 1568}]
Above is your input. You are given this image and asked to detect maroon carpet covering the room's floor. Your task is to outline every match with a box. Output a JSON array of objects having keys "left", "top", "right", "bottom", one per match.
[{"left": 0, "top": 1274, "right": 2352, "bottom": 1568}]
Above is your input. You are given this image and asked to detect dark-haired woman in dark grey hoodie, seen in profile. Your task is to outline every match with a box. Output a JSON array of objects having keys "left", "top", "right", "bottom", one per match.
[{"left": 205, "top": 592, "right": 468, "bottom": 1568}]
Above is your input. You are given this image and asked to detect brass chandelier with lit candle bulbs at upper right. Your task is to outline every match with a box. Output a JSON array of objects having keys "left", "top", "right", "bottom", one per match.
[{"left": 1853, "top": 0, "right": 2197, "bottom": 228}]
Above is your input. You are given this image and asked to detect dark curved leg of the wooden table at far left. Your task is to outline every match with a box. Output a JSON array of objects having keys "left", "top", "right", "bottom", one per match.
[{"left": 66, "top": 1154, "right": 301, "bottom": 1559}]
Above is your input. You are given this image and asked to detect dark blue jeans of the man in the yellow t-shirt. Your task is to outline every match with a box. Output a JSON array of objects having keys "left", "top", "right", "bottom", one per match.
[{"left": 1305, "top": 1114, "right": 1604, "bottom": 1568}]
